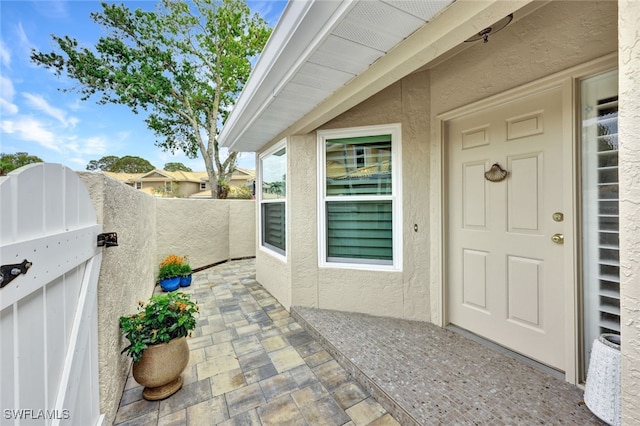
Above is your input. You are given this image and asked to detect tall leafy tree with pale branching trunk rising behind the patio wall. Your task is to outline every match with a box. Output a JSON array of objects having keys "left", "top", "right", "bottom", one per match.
[{"left": 31, "top": 0, "right": 271, "bottom": 198}]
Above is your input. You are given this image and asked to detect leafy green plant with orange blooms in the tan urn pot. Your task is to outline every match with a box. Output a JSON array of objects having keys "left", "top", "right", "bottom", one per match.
[{"left": 120, "top": 292, "right": 198, "bottom": 362}]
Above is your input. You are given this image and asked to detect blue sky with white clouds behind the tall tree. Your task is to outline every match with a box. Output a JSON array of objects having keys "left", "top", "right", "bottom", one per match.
[{"left": 0, "top": 0, "right": 286, "bottom": 171}]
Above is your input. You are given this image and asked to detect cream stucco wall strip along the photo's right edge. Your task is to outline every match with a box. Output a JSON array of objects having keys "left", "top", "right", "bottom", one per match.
[{"left": 618, "top": 0, "right": 640, "bottom": 425}]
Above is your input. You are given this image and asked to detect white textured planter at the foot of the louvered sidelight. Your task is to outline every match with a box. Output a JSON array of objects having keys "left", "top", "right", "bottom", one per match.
[{"left": 584, "top": 333, "right": 622, "bottom": 425}]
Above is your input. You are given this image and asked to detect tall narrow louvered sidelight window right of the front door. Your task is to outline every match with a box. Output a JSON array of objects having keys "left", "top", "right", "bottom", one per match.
[{"left": 581, "top": 71, "right": 620, "bottom": 371}]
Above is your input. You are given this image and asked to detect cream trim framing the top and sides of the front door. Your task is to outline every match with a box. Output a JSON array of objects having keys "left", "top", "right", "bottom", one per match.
[{"left": 429, "top": 52, "right": 618, "bottom": 384}]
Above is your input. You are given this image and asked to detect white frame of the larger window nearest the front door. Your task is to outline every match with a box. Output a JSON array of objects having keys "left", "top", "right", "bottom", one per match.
[{"left": 317, "top": 123, "right": 403, "bottom": 271}]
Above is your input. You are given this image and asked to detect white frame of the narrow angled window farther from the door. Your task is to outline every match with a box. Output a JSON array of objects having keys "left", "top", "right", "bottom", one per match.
[{"left": 255, "top": 140, "right": 289, "bottom": 261}]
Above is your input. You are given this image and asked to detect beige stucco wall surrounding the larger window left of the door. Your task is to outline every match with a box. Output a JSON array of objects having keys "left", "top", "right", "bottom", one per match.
[{"left": 268, "top": 71, "right": 429, "bottom": 320}]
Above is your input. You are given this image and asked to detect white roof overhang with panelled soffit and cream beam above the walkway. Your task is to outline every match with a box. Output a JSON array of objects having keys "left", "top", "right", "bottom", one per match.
[{"left": 219, "top": 0, "right": 545, "bottom": 152}]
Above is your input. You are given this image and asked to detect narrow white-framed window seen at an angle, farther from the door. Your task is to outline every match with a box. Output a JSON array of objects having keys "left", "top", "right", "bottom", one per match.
[{"left": 259, "top": 143, "right": 287, "bottom": 255}]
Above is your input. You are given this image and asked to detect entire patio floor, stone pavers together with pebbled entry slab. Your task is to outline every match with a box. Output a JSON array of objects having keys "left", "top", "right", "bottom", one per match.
[{"left": 116, "top": 259, "right": 602, "bottom": 426}]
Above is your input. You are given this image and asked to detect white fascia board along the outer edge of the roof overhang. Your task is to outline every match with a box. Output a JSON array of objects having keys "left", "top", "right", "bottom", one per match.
[{"left": 218, "top": 0, "right": 353, "bottom": 151}]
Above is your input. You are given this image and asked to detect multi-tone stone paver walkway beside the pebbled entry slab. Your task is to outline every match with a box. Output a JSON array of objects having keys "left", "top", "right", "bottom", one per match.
[{"left": 115, "top": 259, "right": 398, "bottom": 426}]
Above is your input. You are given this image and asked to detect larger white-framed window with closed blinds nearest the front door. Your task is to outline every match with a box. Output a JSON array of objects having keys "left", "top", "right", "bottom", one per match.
[{"left": 318, "top": 125, "right": 402, "bottom": 269}]
